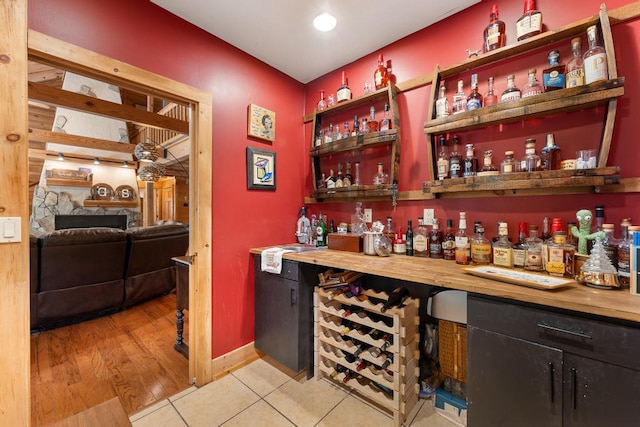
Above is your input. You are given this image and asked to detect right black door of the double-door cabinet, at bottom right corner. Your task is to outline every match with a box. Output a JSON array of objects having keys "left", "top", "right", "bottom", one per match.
[{"left": 563, "top": 353, "right": 640, "bottom": 427}]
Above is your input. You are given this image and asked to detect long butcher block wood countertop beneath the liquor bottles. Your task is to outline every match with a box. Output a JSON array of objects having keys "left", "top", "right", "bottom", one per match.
[{"left": 250, "top": 248, "right": 640, "bottom": 323}]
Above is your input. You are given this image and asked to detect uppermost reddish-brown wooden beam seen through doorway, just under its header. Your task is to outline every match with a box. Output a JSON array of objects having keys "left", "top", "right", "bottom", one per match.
[{"left": 29, "top": 82, "right": 189, "bottom": 134}]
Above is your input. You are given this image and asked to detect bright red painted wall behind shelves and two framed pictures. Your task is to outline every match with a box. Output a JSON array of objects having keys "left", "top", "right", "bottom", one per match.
[{"left": 29, "top": 0, "right": 640, "bottom": 357}]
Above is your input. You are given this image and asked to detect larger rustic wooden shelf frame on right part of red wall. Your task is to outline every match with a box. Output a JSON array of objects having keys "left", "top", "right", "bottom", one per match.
[{"left": 423, "top": 4, "right": 625, "bottom": 197}]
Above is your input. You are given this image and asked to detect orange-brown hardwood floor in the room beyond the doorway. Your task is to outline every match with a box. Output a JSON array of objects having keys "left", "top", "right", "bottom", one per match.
[{"left": 31, "top": 293, "right": 190, "bottom": 426}]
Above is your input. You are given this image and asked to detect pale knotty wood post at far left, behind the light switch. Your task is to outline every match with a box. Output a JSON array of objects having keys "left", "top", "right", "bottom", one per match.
[{"left": 0, "top": 0, "right": 31, "bottom": 426}]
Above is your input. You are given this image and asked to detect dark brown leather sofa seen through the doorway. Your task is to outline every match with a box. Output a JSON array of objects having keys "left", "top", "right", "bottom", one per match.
[{"left": 30, "top": 223, "right": 189, "bottom": 329}]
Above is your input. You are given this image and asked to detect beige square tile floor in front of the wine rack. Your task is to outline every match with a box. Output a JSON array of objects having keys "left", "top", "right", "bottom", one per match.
[{"left": 130, "top": 359, "right": 456, "bottom": 427}]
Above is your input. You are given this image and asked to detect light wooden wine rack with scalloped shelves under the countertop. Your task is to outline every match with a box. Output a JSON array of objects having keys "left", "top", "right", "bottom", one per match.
[{"left": 314, "top": 288, "right": 420, "bottom": 426}]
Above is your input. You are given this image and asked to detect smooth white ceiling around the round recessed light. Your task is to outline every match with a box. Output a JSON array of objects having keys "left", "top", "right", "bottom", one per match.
[{"left": 151, "top": 0, "right": 480, "bottom": 83}]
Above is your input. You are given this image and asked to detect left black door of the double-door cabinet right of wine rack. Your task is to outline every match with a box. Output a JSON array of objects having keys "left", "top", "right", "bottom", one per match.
[{"left": 467, "top": 326, "right": 562, "bottom": 427}]
